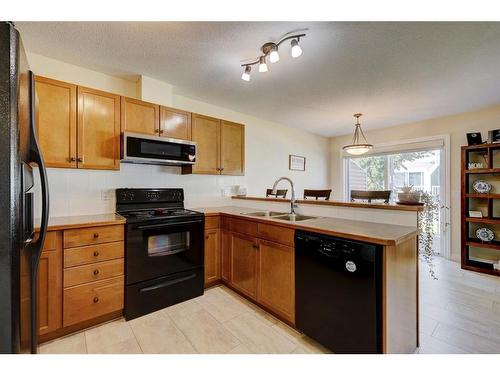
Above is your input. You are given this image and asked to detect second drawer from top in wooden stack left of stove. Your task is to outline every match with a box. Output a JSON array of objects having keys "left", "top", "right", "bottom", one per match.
[{"left": 64, "top": 241, "right": 123, "bottom": 268}]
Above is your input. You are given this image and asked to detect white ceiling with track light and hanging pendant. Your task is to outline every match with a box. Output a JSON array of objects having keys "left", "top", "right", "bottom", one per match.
[{"left": 17, "top": 22, "right": 500, "bottom": 136}]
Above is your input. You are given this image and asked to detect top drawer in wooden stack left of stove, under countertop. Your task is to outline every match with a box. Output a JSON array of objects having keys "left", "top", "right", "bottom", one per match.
[{"left": 64, "top": 224, "right": 123, "bottom": 247}]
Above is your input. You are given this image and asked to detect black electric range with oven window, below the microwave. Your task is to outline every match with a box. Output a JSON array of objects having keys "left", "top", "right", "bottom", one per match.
[{"left": 116, "top": 189, "right": 204, "bottom": 320}]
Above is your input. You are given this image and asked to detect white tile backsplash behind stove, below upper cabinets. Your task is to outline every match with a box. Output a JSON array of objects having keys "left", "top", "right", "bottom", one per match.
[{"left": 35, "top": 163, "right": 245, "bottom": 217}]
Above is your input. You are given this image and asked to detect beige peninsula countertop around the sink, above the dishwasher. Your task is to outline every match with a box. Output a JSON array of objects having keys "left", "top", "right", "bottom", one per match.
[{"left": 193, "top": 206, "right": 417, "bottom": 245}]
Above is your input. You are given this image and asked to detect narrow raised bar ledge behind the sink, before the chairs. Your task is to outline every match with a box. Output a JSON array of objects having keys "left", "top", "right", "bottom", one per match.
[{"left": 231, "top": 196, "right": 423, "bottom": 212}]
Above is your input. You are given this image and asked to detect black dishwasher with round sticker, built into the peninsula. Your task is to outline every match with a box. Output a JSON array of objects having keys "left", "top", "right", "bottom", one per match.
[{"left": 295, "top": 231, "right": 382, "bottom": 354}]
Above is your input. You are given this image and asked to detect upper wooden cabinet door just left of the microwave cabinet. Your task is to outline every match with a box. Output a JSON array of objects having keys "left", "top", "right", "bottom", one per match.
[{"left": 78, "top": 86, "right": 120, "bottom": 169}]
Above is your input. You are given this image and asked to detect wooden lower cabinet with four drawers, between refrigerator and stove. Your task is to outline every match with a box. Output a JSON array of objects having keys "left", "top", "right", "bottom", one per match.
[{"left": 36, "top": 224, "right": 124, "bottom": 342}]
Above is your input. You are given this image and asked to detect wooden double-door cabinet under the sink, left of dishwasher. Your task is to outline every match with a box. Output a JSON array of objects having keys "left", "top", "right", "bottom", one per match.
[{"left": 220, "top": 217, "right": 295, "bottom": 324}]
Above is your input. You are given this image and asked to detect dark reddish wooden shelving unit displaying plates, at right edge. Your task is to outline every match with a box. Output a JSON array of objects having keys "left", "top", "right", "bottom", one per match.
[{"left": 461, "top": 143, "right": 500, "bottom": 276}]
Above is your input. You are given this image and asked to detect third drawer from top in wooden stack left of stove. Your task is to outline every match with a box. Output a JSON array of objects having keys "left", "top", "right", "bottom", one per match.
[{"left": 64, "top": 259, "right": 124, "bottom": 288}]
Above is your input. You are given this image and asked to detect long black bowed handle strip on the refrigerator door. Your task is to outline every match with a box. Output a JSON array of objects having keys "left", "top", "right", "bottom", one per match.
[{"left": 28, "top": 71, "right": 49, "bottom": 354}]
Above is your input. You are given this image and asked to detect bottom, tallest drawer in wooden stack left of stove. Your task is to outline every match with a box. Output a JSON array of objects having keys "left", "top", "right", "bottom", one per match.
[{"left": 63, "top": 276, "right": 124, "bottom": 327}]
